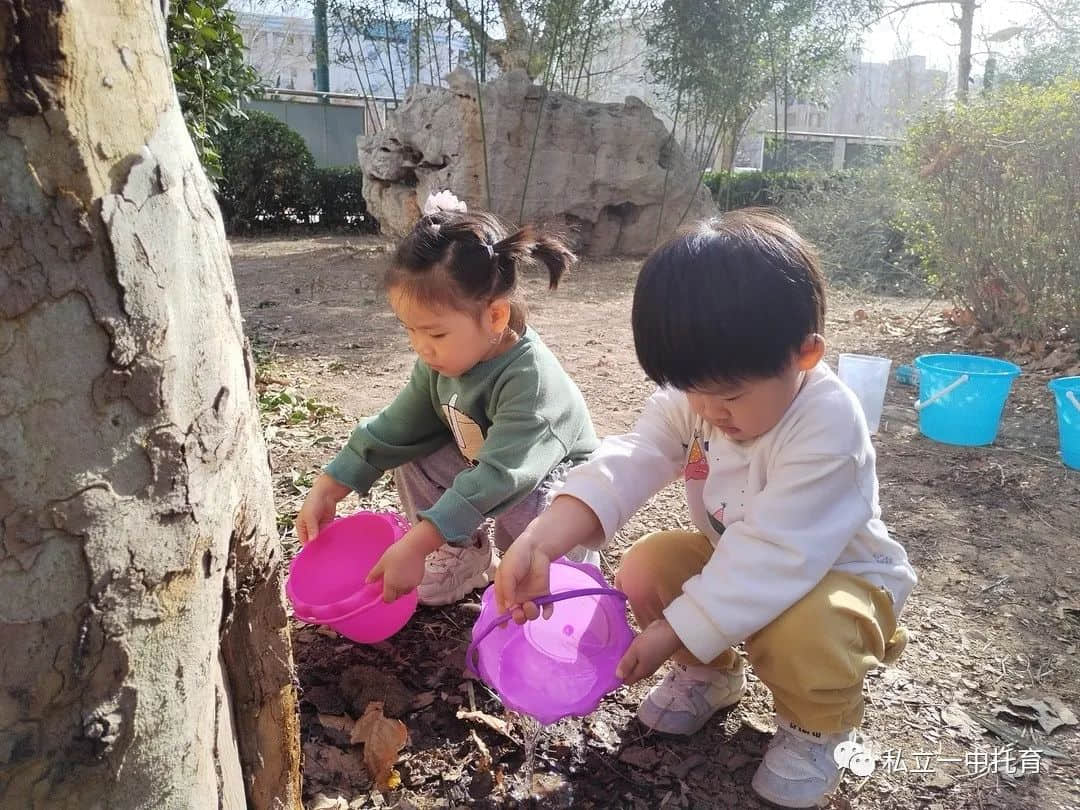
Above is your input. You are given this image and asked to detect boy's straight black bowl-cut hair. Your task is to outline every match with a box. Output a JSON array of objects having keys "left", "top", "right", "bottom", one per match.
[{"left": 632, "top": 208, "right": 825, "bottom": 390}]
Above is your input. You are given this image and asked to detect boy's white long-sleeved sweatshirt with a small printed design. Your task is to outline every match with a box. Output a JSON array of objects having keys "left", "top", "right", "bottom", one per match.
[{"left": 561, "top": 363, "right": 916, "bottom": 661}]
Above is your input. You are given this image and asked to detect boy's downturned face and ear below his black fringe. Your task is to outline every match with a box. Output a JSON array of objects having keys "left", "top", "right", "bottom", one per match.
[{"left": 686, "top": 335, "right": 825, "bottom": 442}]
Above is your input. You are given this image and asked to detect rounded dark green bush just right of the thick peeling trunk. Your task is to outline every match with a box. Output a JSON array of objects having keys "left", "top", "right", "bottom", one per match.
[{"left": 219, "top": 110, "right": 315, "bottom": 231}]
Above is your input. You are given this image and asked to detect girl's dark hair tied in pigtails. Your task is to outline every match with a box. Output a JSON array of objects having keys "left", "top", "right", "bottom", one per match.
[{"left": 386, "top": 211, "right": 577, "bottom": 332}]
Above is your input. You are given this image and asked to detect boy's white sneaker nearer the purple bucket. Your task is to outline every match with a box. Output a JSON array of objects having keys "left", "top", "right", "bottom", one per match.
[{"left": 637, "top": 664, "right": 746, "bottom": 735}]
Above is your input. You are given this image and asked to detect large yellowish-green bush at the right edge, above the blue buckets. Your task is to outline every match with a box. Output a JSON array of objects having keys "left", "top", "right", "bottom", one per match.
[{"left": 903, "top": 79, "right": 1080, "bottom": 337}]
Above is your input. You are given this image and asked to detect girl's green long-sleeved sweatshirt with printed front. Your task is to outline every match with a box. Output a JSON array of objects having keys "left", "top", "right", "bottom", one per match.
[{"left": 326, "top": 328, "right": 598, "bottom": 544}]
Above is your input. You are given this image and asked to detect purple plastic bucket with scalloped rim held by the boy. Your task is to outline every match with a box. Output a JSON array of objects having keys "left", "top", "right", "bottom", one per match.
[{"left": 465, "top": 559, "right": 634, "bottom": 725}]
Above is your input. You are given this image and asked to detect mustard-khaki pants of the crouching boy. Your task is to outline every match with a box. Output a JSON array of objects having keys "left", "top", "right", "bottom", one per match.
[{"left": 616, "top": 531, "right": 907, "bottom": 733}]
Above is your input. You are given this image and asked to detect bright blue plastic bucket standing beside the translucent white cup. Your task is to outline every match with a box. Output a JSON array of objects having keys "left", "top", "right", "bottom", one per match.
[{"left": 915, "top": 354, "right": 1020, "bottom": 447}]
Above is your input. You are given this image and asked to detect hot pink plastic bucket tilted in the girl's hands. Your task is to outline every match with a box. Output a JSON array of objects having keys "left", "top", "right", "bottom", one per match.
[{"left": 285, "top": 512, "right": 417, "bottom": 644}]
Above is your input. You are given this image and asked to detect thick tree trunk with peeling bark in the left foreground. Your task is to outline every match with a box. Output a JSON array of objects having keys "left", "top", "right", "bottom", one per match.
[{"left": 0, "top": 0, "right": 300, "bottom": 810}]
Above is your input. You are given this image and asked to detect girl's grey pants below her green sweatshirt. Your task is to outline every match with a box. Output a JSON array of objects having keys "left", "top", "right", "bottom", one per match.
[{"left": 394, "top": 442, "right": 598, "bottom": 564}]
